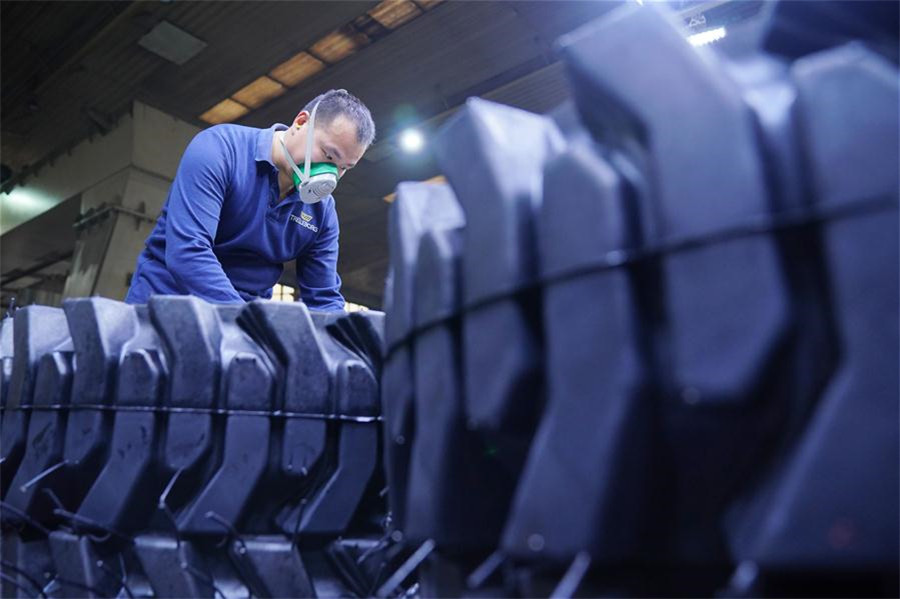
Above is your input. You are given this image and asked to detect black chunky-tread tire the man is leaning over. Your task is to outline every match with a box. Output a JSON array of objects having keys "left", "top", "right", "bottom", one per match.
[{"left": 0, "top": 296, "right": 391, "bottom": 597}]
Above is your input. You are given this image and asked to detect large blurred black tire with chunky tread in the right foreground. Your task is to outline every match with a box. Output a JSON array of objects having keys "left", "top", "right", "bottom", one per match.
[{"left": 382, "top": 2, "right": 900, "bottom": 596}]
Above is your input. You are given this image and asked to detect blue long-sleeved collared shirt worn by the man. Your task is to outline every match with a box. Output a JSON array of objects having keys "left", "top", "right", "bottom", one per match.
[{"left": 125, "top": 124, "right": 344, "bottom": 310}]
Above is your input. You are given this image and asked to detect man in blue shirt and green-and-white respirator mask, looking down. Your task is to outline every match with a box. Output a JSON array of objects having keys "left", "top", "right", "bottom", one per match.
[{"left": 125, "top": 90, "right": 375, "bottom": 310}]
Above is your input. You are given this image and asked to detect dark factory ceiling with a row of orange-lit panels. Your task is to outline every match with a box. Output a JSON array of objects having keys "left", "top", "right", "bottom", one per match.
[{"left": 0, "top": 0, "right": 758, "bottom": 306}]
